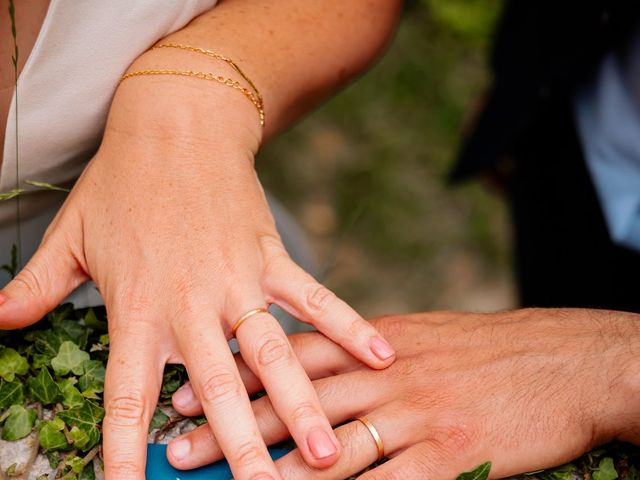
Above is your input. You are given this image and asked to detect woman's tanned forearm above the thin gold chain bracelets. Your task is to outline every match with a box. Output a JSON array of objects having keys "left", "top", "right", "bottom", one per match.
[{"left": 128, "top": 0, "right": 401, "bottom": 142}]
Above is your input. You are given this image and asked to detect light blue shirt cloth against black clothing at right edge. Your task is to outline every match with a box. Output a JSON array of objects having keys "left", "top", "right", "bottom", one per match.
[{"left": 574, "top": 25, "right": 640, "bottom": 251}]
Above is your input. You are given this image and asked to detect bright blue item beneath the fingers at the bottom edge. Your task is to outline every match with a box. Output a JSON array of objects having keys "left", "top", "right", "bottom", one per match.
[{"left": 145, "top": 444, "right": 289, "bottom": 480}]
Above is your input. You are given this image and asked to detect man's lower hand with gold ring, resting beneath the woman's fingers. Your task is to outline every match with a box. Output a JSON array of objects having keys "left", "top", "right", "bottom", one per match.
[{"left": 169, "top": 310, "right": 640, "bottom": 480}]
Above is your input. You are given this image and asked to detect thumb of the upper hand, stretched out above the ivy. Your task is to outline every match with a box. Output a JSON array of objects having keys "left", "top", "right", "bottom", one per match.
[{"left": 0, "top": 236, "right": 88, "bottom": 329}]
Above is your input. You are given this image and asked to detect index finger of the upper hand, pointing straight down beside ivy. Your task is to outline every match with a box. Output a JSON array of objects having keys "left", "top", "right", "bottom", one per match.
[{"left": 103, "top": 318, "right": 163, "bottom": 480}]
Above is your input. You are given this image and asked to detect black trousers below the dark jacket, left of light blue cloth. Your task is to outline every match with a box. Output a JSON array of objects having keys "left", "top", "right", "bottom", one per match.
[{"left": 510, "top": 104, "right": 640, "bottom": 312}]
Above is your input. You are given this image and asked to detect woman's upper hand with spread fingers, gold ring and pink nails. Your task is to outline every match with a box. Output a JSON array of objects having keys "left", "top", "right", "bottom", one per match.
[{"left": 0, "top": 72, "right": 394, "bottom": 480}]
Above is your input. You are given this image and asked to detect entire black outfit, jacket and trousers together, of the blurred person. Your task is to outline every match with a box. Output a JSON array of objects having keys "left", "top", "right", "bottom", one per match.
[{"left": 452, "top": 0, "right": 640, "bottom": 312}]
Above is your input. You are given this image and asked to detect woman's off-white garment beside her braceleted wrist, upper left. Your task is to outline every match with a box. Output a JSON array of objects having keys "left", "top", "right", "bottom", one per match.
[{"left": 0, "top": 0, "right": 217, "bottom": 306}]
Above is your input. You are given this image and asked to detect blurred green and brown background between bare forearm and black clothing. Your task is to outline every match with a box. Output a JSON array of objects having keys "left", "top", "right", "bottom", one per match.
[{"left": 257, "top": 0, "right": 515, "bottom": 317}]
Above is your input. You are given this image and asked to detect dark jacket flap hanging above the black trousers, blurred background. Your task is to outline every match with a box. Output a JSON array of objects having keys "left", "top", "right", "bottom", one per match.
[{"left": 451, "top": 0, "right": 640, "bottom": 180}]
